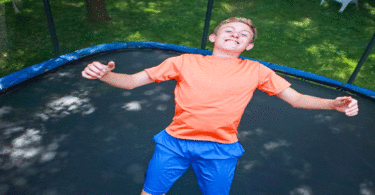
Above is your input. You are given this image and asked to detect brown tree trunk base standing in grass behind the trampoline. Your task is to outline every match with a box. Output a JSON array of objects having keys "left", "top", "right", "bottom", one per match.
[{"left": 86, "top": 0, "right": 111, "bottom": 22}]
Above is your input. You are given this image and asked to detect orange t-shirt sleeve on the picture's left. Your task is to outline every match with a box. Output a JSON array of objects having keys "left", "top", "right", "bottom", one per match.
[{"left": 145, "top": 56, "right": 182, "bottom": 83}]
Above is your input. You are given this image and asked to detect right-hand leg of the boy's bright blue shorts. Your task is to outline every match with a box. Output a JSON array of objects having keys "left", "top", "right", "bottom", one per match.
[{"left": 191, "top": 158, "right": 238, "bottom": 195}]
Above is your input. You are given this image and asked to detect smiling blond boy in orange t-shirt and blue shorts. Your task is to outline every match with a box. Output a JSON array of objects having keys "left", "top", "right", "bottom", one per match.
[{"left": 82, "top": 18, "right": 358, "bottom": 195}]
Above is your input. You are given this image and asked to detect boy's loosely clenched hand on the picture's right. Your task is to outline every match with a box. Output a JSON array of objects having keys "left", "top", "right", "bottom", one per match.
[{"left": 332, "top": 96, "right": 358, "bottom": 116}]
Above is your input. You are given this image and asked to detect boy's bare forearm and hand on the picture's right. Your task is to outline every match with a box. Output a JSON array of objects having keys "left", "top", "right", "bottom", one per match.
[{"left": 277, "top": 87, "right": 358, "bottom": 116}]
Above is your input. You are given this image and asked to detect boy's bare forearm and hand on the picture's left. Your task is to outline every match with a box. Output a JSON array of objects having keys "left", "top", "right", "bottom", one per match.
[{"left": 82, "top": 61, "right": 154, "bottom": 90}]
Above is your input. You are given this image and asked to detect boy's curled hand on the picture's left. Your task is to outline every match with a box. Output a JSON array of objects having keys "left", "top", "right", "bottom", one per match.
[{"left": 82, "top": 61, "right": 115, "bottom": 79}]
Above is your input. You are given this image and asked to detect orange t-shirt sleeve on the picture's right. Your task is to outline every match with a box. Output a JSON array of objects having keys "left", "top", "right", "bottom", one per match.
[{"left": 258, "top": 65, "right": 291, "bottom": 96}]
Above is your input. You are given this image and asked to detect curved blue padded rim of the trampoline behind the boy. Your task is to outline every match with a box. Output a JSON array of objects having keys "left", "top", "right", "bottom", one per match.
[{"left": 0, "top": 41, "right": 375, "bottom": 99}]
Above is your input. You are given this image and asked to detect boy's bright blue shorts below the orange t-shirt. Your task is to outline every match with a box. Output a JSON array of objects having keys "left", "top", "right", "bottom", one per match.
[{"left": 143, "top": 130, "right": 244, "bottom": 195}]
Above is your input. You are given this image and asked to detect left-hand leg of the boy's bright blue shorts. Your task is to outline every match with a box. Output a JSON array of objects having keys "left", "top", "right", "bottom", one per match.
[{"left": 142, "top": 144, "right": 190, "bottom": 195}]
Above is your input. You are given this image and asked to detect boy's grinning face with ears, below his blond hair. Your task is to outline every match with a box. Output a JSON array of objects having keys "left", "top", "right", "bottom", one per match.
[{"left": 209, "top": 22, "right": 254, "bottom": 53}]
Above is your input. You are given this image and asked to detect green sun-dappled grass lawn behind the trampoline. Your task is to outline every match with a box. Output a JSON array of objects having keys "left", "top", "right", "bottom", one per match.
[{"left": 0, "top": 0, "right": 375, "bottom": 90}]
